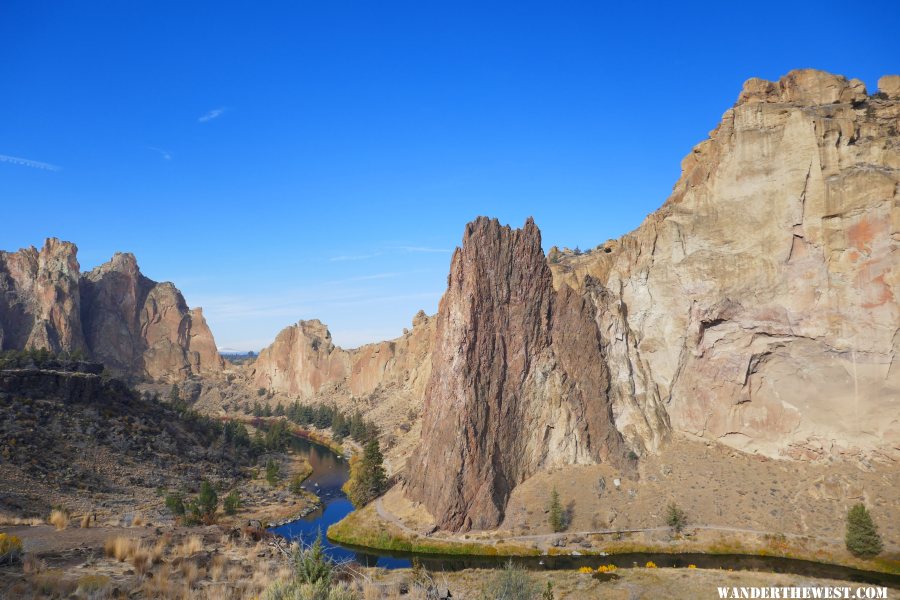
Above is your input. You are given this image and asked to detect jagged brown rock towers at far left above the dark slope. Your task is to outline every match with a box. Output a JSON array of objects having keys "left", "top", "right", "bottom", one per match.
[{"left": 0, "top": 238, "right": 223, "bottom": 380}]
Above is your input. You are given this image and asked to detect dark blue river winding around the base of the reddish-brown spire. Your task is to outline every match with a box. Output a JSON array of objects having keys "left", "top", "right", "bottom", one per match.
[{"left": 272, "top": 437, "right": 900, "bottom": 588}]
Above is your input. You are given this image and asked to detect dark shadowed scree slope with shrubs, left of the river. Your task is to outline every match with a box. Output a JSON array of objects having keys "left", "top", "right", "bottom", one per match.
[{"left": 0, "top": 358, "right": 243, "bottom": 516}]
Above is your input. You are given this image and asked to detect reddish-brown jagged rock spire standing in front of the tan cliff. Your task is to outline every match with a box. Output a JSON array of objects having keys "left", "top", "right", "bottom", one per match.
[{"left": 408, "top": 217, "right": 625, "bottom": 530}]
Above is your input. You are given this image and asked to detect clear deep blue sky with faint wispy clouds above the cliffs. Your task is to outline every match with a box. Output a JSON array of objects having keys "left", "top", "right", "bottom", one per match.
[{"left": 0, "top": 0, "right": 900, "bottom": 350}]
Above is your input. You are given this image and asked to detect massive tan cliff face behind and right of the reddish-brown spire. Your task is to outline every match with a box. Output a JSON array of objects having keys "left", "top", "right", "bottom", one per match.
[{"left": 553, "top": 71, "right": 900, "bottom": 458}]
